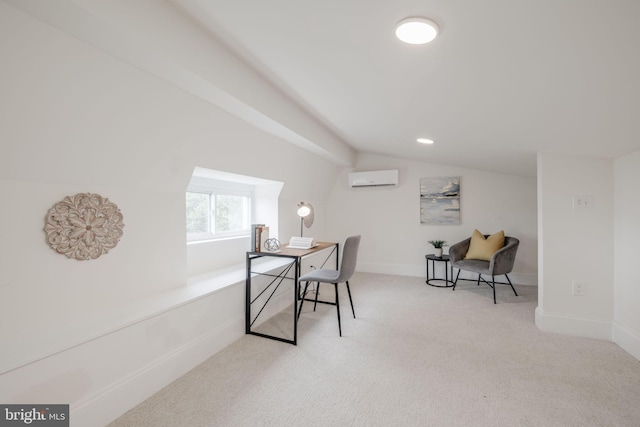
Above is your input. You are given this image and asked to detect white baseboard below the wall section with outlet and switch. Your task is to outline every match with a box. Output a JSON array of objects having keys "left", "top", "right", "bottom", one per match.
[{"left": 535, "top": 307, "right": 612, "bottom": 341}]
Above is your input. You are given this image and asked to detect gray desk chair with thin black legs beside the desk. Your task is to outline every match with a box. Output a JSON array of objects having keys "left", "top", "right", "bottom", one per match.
[{"left": 298, "top": 236, "right": 360, "bottom": 336}]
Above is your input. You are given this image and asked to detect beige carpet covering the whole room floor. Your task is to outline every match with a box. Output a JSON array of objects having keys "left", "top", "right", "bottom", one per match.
[{"left": 111, "top": 273, "right": 640, "bottom": 427}]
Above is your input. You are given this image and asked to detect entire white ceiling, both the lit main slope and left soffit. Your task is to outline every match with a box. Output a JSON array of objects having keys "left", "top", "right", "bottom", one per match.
[{"left": 3, "top": 0, "right": 640, "bottom": 176}]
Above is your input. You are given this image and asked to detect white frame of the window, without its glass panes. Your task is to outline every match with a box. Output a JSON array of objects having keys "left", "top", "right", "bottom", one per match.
[{"left": 187, "top": 176, "right": 254, "bottom": 242}]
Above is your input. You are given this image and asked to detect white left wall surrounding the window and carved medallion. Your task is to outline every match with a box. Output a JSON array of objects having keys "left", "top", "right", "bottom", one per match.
[{"left": 0, "top": 2, "right": 337, "bottom": 426}]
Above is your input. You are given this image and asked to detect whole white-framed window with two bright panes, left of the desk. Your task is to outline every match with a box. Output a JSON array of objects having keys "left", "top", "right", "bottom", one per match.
[{"left": 186, "top": 177, "right": 253, "bottom": 241}]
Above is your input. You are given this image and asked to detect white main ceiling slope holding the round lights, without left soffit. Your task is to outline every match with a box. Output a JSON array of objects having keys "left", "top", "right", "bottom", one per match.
[{"left": 166, "top": 0, "right": 640, "bottom": 176}]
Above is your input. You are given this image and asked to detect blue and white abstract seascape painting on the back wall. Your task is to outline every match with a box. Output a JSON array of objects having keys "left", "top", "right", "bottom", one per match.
[{"left": 420, "top": 176, "right": 460, "bottom": 225}]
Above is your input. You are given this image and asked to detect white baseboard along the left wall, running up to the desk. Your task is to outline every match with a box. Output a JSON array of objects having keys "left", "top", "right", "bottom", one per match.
[{"left": 70, "top": 316, "right": 244, "bottom": 427}]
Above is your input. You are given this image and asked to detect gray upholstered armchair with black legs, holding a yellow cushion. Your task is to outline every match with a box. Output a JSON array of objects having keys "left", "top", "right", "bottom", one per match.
[{"left": 449, "top": 235, "right": 520, "bottom": 304}]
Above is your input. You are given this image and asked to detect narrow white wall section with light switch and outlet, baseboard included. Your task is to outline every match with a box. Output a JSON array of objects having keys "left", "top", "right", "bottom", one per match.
[{"left": 536, "top": 153, "right": 614, "bottom": 340}]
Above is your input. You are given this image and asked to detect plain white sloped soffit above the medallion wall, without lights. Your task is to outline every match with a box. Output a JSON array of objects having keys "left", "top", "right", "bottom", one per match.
[{"left": 2, "top": 0, "right": 354, "bottom": 169}]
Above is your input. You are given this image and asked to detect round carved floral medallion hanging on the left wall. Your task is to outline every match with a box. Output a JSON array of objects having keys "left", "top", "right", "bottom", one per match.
[{"left": 44, "top": 193, "right": 124, "bottom": 260}]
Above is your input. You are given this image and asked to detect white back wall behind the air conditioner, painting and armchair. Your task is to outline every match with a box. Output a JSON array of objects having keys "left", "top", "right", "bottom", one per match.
[{"left": 328, "top": 154, "right": 537, "bottom": 285}]
